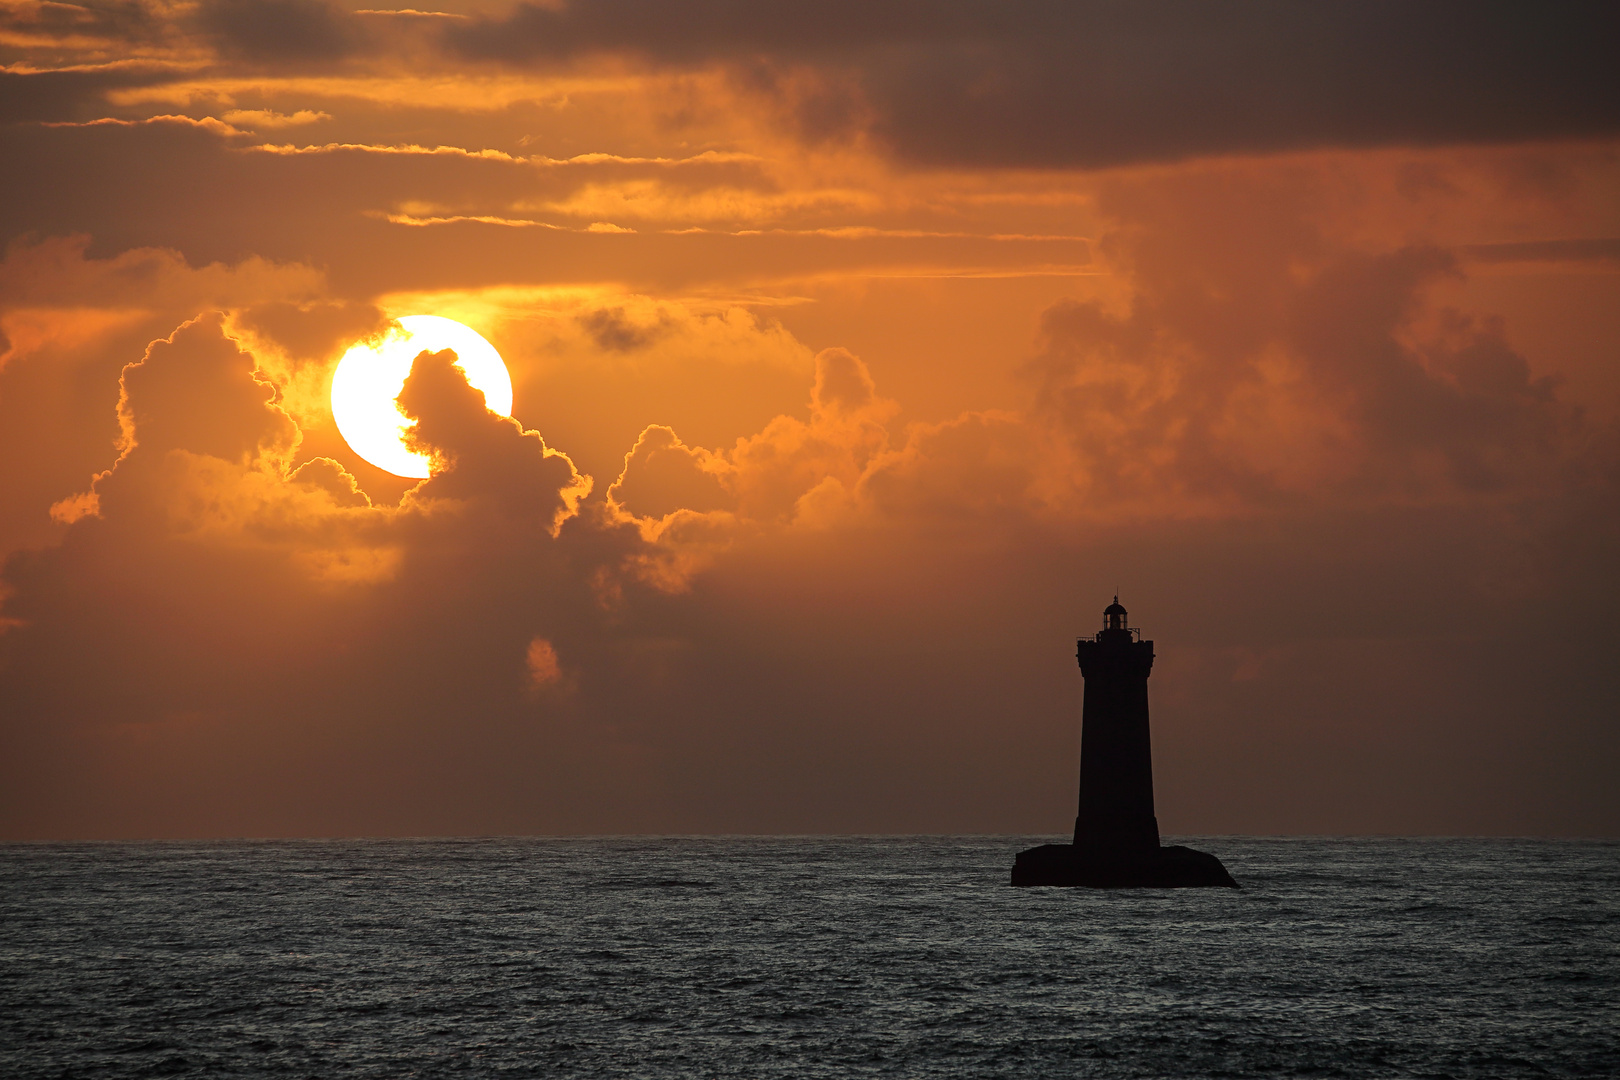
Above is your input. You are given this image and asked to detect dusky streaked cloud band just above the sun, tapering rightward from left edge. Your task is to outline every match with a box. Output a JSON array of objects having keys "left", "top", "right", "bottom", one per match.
[{"left": 0, "top": 117, "right": 1087, "bottom": 296}]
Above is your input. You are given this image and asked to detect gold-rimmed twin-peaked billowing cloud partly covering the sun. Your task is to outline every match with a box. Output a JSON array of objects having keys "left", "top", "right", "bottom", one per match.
[{"left": 20, "top": 313, "right": 624, "bottom": 637}]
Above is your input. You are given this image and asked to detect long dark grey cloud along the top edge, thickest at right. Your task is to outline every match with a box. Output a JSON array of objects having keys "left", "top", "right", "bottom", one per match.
[{"left": 444, "top": 0, "right": 1620, "bottom": 167}]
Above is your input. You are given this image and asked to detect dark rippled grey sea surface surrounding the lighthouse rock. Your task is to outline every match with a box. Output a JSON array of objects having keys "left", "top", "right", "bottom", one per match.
[{"left": 0, "top": 837, "right": 1620, "bottom": 1078}]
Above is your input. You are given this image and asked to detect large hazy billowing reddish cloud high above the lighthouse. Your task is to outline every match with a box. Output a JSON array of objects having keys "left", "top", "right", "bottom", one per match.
[{"left": 1010, "top": 163, "right": 1583, "bottom": 508}]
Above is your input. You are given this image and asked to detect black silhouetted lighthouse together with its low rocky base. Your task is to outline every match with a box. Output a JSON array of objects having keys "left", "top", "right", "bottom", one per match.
[{"left": 1013, "top": 596, "right": 1238, "bottom": 889}]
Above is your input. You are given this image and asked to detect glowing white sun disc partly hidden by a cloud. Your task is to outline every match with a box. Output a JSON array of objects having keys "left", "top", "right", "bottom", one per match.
[{"left": 332, "top": 316, "right": 512, "bottom": 478}]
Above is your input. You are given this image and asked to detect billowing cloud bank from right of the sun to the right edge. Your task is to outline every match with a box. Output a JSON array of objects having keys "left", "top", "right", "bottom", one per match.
[{"left": 609, "top": 153, "right": 1612, "bottom": 578}]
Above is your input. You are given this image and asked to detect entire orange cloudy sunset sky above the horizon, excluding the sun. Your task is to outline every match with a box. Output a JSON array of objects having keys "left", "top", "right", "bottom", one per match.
[{"left": 0, "top": 0, "right": 1620, "bottom": 840}]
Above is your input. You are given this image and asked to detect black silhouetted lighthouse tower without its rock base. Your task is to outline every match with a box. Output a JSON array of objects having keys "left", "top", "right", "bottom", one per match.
[{"left": 1074, "top": 596, "right": 1158, "bottom": 860}]
